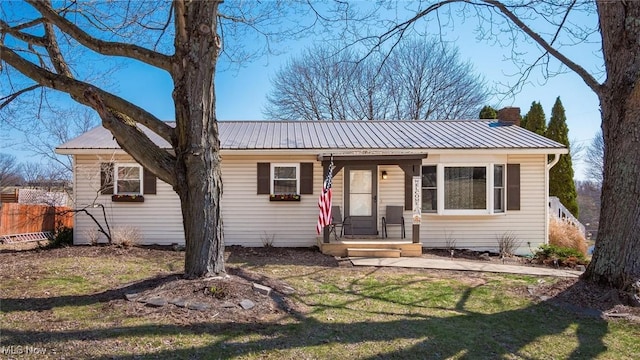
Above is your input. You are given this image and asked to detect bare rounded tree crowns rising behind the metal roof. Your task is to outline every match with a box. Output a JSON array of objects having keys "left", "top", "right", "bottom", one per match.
[{"left": 264, "top": 39, "right": 488, "bottom": 120}]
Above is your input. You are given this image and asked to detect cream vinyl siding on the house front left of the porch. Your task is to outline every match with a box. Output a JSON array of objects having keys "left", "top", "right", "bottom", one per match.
[{"left": 74, "top": 155, "right": 344, "bottom": 246}]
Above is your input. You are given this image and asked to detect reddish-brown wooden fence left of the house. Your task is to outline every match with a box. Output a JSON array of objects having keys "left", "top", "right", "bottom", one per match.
[{"left": 0, "top": 203, "right": 73, "bottom": 235}]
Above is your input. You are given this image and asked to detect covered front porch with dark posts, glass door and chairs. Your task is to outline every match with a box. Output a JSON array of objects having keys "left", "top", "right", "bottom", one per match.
[{"left": 317, "top": 153, "right": 427, "bottom": 248}]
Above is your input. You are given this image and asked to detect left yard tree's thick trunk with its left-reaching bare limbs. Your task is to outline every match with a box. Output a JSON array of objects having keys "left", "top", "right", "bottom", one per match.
[{"left": 0, "top": 0, "right": 224, "bottom": 277}]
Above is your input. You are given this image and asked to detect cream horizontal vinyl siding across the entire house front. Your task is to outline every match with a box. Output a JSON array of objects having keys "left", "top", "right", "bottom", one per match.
[{"left": 74, "top": 153, "right": 547, "bottom": 253}]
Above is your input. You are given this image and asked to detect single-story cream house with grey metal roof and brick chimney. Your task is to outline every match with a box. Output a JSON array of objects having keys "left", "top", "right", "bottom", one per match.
[{"left": 57, "top": 108, "right": 568, "bottom": 253}]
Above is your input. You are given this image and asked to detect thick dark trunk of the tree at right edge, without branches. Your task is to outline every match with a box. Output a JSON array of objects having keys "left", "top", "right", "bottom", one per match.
[{"left": 583, "top": 1, "right": 640, "bottom": 289}]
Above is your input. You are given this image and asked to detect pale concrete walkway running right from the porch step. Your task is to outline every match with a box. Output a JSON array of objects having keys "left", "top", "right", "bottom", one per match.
[{"left": 351, "top": 257, "right": 582, "bottom": 278}]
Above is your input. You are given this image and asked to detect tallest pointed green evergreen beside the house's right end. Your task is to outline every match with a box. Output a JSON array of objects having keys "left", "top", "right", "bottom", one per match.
[{"left": 545, "top": 97, "right": 578, "bottom": 217}]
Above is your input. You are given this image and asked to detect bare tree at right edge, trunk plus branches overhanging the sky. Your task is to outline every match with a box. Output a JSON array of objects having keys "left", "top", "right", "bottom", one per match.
[{"left": 358, "top": 0, "right": 640, "bottom": 290}]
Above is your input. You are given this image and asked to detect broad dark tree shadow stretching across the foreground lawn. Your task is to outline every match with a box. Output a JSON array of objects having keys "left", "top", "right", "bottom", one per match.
[{"left": 2, "top": 282, "right": 608, "bottom": 359}]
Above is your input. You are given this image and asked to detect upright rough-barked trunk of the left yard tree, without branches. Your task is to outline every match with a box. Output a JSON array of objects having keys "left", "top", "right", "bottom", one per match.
[{"left": 172, "top": 1, "right": 224, "bottom": 278}]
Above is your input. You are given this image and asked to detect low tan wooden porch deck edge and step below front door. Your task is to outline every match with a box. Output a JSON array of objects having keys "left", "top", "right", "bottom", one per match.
[{"left": 317, "top": 237, "right": 422, "bottom": 257}]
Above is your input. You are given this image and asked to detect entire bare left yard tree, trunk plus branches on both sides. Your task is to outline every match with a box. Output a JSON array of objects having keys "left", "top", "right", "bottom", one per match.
[{"left": 0, "top": 0, "right": 302, "bottom": 278}]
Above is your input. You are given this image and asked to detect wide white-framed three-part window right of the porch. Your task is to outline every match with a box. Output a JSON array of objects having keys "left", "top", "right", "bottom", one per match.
[{"left": 422, "top": 164, "right": 506, "bottom": 215}]
